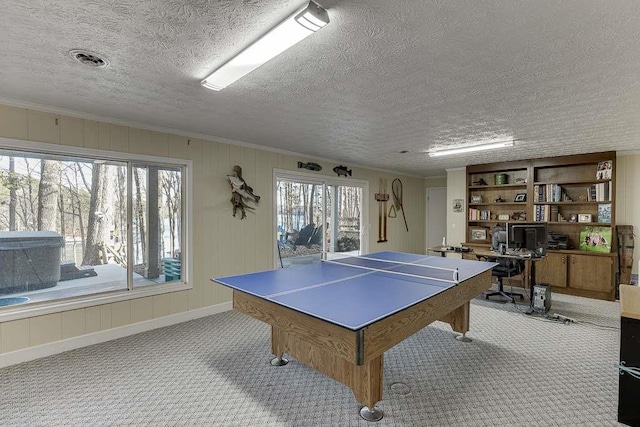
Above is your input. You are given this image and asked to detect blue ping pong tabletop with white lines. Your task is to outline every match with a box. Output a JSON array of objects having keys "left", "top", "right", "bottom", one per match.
[{"left": 212, "top": 252, "right": 496, "bottom": 330}]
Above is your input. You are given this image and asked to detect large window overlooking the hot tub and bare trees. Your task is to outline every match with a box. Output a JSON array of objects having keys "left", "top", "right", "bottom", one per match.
[{"left": 0, "top": 144, "right": 188, "bottom": 309}]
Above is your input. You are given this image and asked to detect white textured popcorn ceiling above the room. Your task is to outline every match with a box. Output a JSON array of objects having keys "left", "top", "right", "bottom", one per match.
[{"left": 0, "top": 0, "right": 640, "bottom": 176}]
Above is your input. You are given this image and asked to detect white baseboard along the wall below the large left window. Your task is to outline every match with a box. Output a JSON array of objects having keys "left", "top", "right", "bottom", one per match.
[{"left": 0, "top": 302, "right": 233, "bottom": 368}]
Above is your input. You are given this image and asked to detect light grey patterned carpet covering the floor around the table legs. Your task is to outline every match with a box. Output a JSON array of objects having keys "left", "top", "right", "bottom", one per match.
[{"left": 0, "top": 294, "right": 622, "bottom": 427}]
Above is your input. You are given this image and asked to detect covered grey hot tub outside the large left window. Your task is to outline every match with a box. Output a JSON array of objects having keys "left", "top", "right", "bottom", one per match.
[{"left": 0, "top": 231, "right": 64, "bottom": 294}]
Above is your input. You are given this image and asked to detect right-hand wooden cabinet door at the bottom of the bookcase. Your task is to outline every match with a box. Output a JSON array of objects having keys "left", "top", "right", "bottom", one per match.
[{"left": 569, "top": 255, "right": 613, "bottom": 293}]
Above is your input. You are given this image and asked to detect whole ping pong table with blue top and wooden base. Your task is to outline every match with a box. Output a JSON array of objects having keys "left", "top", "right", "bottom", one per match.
[{"left": 212, "top": 252, "right": 496, "bottom": 421}]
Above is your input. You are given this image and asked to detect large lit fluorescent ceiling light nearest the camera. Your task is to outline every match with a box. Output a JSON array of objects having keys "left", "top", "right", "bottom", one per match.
[{"left": 201, "top": 1, "right": 329, "bottom": 90}]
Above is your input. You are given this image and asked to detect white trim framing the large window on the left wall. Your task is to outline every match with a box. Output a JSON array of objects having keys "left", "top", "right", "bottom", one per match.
[{"left": 0, "top": 137, "right": 193, "bottom": 323}]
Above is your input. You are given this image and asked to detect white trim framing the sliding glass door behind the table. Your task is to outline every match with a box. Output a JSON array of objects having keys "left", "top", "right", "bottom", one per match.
[{"left": 272, "top": 168, "right": 369, "bottom": 268}]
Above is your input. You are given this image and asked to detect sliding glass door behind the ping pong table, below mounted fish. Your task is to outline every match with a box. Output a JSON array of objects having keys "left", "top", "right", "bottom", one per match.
[{"left": 274, "top": 170, "right": 368, "bottom": 268}]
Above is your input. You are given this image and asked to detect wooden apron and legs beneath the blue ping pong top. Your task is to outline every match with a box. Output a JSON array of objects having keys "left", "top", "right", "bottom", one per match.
[{"left": 233, "top": 270, "right": 491, "bottom": 408}]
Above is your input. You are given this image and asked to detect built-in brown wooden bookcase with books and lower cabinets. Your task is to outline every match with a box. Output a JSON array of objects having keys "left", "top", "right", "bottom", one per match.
[{"left": 467, "top": 151, "right": 617, "bottom": 300}]
